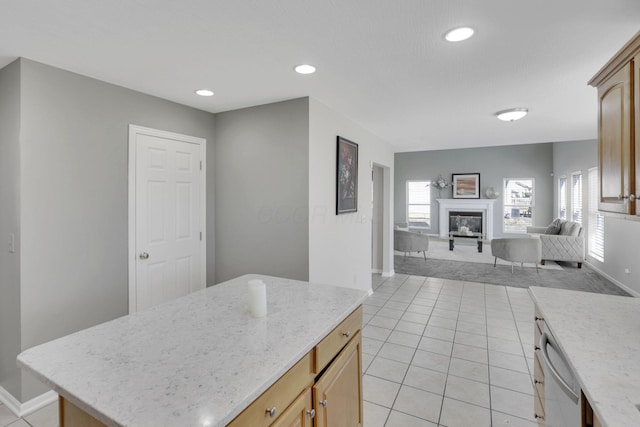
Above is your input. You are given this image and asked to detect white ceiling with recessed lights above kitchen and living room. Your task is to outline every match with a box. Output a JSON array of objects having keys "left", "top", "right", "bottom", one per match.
[{"left": 0, "top": 0, "right": 640, "bottom": 151}]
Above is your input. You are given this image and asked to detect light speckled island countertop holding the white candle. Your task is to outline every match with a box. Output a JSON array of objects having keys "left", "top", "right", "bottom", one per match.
[{"left": 18, "top": 275, "right": 368, "bottom": 427}]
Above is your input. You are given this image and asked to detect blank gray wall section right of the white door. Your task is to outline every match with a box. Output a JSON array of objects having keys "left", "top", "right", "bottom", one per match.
[{"left": 215, "top": 98, "right": 309, "bottom": 283}]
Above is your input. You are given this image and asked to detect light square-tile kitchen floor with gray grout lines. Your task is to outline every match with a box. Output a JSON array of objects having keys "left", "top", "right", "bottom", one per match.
[{"left": 0, "top": 275, "right": 536, "bottom": 427}]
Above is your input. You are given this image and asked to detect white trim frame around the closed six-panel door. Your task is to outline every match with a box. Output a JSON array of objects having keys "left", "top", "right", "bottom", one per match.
[{"left": 128, "top": 124, "right": 207, "bottom": 314}]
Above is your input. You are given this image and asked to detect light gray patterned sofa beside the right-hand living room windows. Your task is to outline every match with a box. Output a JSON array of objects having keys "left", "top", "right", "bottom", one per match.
[{"left": 527, "top": 219, "right": 585, "bottom": 268}]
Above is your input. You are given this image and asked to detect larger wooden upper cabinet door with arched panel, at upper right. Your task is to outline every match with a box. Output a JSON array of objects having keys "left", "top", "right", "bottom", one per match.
[{"left": 598, "top": 64, "right": 635, "bottom": 214}]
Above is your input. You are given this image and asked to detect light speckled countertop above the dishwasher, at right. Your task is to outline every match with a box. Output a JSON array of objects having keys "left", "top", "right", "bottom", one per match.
[{"left": 529, "top": 287, "right": 640, "bottom": 427}]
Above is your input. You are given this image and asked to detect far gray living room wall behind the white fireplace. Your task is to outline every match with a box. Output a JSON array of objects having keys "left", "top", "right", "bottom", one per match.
[{"left": 394, "top": 143, "right": 553, "bottom": 237}]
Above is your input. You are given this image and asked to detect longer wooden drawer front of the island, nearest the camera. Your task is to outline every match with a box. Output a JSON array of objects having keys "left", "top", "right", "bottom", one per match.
[{"left": 227, "top": 352, "right": 314, "bottom": 427}]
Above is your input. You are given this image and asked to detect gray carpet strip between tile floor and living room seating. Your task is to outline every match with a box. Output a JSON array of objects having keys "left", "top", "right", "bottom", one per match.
[{"left": 394, "top": 255, "right": 628, "bottom": 296}]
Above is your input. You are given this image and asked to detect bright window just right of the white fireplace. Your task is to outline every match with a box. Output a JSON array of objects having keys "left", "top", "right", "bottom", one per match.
[{"left": 502, "top": 178, "right": 534, "bottom": 234}]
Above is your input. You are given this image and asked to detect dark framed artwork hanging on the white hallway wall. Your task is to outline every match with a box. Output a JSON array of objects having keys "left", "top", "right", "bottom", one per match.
[{"left": 336, "top": 136, "right": 358, "bottom": 215}]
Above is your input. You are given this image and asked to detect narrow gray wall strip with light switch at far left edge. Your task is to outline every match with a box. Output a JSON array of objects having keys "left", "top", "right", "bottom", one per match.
[{"left": 0, "top": 61, "right": 22, "bottom": 396}]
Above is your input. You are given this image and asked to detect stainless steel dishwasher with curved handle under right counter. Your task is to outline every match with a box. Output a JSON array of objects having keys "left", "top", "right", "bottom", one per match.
[{"left": 540, "top": 325, "right": 582, "bottom": 427}]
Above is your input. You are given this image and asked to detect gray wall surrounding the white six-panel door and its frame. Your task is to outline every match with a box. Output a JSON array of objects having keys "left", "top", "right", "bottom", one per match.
[{"left": 8, "top": 59, "right": 215, "bottom": 401}]
